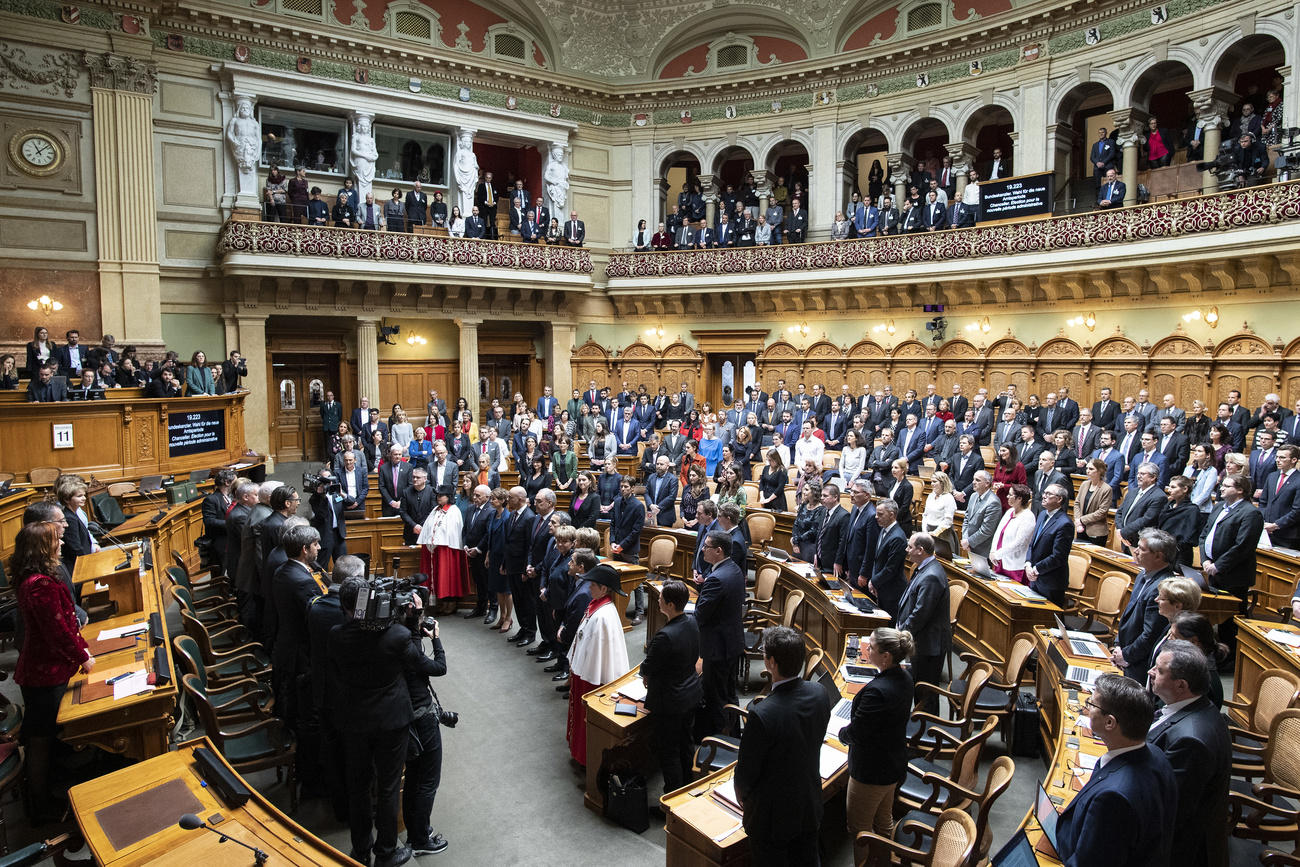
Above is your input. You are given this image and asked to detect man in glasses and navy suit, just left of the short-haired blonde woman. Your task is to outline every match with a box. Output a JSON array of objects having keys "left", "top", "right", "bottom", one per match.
[{"left": 1110, "top": 526, "right": 1178, "bottom": 684}]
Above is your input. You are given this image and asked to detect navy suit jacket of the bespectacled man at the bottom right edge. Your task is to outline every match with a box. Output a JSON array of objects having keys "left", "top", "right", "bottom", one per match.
[{"left": 1057, "top": 746, "right": 1186, "bottom": 867}]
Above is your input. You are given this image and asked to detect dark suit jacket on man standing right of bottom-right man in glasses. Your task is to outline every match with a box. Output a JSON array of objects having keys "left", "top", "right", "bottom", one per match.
[{"left": 1147, "top": 696, "right": 1232, "bottom": 867}]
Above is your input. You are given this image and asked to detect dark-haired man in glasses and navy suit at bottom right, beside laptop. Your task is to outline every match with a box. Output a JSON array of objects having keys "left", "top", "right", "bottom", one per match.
[{"left": 1057, "top": 675, "right": 1190, "bottom": 867}]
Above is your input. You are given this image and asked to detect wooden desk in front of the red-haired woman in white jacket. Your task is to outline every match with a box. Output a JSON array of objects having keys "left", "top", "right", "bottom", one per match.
[{"left": 940, "top": 560, "right": 1061, "bottom": 662}]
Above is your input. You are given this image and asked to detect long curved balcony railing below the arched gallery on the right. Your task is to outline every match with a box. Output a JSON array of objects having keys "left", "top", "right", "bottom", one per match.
[{"left": 605, "top": 181, "right": 1300, "bottom": 279}]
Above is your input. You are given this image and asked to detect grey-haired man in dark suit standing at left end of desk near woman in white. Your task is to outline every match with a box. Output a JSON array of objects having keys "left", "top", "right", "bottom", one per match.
[{"left": 897, "top": 533, "right": 953, "bottom": 715}]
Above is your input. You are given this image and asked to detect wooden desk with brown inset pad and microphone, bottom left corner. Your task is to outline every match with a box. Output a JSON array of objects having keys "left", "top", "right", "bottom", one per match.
[{"left": 68, "top": 738, "right": 359, "bottom": 867}]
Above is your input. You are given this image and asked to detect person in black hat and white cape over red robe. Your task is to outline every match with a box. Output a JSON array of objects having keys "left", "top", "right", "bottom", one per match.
[{"left": 568, "top": 563, "right": 632, "bottom": 767}]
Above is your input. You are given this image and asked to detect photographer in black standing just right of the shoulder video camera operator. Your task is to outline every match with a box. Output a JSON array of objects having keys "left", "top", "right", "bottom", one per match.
[{"left": 402, "top": 588, "right": 458, "bottom": 855}]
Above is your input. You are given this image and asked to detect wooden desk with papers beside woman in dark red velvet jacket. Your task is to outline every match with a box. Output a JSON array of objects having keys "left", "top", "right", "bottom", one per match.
[{"left": 59, "top": 550, "right": 179, "bottom": 759}]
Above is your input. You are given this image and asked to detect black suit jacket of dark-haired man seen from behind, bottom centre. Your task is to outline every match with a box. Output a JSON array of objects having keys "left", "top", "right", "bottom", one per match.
[{"left": 735, "top": 677, "right": 831, "bottom": 845}]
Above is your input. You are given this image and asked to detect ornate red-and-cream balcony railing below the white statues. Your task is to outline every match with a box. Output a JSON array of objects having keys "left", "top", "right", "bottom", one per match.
[{"left": 217, "top": 221, "right": 592, "bottom": 274}]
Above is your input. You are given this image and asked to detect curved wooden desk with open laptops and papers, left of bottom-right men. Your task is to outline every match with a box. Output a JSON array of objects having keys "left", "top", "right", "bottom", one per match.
[{"left": 1021, "top": 629, "right": 1121, "bottom": 864}]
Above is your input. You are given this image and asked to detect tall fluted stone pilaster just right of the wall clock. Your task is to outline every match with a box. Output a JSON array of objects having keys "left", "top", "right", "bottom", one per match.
[{"left": 82, "top": 52, "right": 163, "bottom": 346}]
